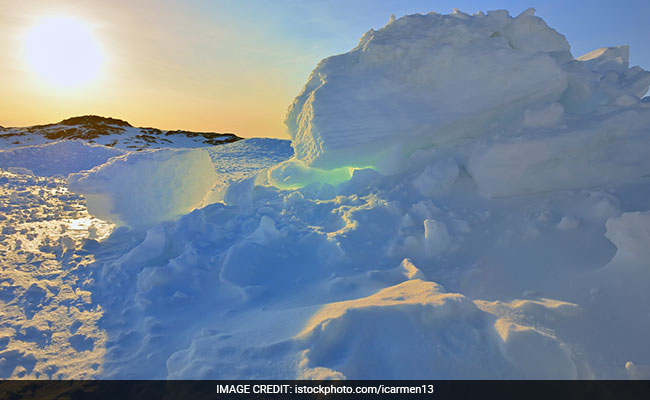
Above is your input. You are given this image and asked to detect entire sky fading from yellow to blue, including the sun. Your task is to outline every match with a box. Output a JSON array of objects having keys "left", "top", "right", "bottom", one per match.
[{"left": 0, "top": 0, "right": 650, "bottom": 138}]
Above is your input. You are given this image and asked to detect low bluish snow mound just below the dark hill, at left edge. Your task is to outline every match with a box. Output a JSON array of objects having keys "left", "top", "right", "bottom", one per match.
[{"left": 0, "top": 140, "right": 124, "bottom": 176}]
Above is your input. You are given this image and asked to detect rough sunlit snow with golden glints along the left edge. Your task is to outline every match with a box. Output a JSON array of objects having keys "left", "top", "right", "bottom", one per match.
[{"left": 0, "top": 170, "right": 112, "bottom": 379}]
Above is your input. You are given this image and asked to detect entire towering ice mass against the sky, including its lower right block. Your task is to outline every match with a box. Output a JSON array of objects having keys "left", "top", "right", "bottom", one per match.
[{"left": 286, "top": 9, "right": 650, "bottom": 186}]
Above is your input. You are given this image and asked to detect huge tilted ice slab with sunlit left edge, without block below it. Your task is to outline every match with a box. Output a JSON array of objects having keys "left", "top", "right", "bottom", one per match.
[{"left": 286, "top": 13, "right": 571, "bottom": 169}]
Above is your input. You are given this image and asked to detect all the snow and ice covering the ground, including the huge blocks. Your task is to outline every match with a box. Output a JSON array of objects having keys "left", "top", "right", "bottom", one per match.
[{"left": 0, "top": 10, "right": 650, "bottom": 379}]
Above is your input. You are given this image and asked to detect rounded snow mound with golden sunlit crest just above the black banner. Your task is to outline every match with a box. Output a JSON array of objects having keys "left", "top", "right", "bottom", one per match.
[{"left": 298, "top": 279, "right": 578, "bottom": 379}]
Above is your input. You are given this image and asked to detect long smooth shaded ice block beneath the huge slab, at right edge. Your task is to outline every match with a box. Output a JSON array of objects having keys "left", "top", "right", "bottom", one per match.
[{"left": 467, "top": 109, "right": 650, "bottom": 197}]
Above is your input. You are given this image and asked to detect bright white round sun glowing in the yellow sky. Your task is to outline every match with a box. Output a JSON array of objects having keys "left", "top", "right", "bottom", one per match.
[{"left": 25, "top": 16, "right": 104, "bottom": 89}]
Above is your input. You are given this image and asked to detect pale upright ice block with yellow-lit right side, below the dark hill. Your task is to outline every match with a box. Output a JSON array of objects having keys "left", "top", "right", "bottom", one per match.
[{"left": 68, "top": 149, "right": 217, "bottom": 229}]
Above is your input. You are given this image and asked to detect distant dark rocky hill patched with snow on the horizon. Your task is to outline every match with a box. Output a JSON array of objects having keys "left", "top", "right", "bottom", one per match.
[{"left": 0, "top": 115, "right": 241, "bottom": 150}]
